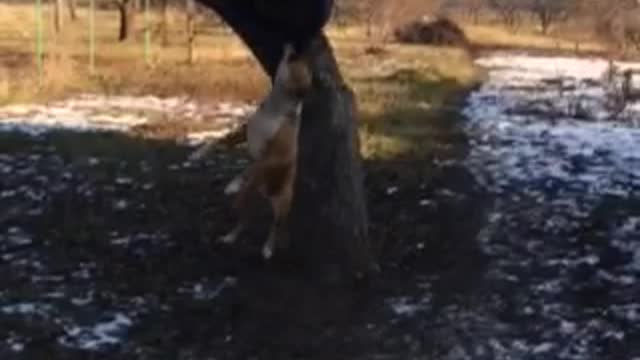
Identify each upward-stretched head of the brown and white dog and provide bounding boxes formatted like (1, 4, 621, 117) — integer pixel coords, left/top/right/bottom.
(274, 44, 313, 98)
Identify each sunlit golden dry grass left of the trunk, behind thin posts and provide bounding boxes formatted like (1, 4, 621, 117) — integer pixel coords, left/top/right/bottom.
(0, 5, 267, 103)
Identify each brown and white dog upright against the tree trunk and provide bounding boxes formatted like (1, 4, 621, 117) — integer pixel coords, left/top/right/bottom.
(191, 45, 311, 259)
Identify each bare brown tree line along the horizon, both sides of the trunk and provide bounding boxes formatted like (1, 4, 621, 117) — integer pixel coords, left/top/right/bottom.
(13, 0, 640, 57)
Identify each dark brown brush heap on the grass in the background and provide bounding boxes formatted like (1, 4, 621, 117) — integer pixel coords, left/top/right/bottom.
(394, 18, 469, 49)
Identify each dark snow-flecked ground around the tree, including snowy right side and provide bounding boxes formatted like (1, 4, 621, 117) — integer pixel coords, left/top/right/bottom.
(0, 52, 640, 360)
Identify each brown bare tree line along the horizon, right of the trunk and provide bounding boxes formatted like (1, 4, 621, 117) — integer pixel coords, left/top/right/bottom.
(334, 0, 640, 51)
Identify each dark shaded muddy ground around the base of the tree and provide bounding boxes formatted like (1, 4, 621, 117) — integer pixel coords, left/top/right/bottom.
(0, 91, 487, 359)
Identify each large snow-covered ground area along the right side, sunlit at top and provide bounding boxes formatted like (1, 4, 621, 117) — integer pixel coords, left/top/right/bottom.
(443, 55, 640, 360)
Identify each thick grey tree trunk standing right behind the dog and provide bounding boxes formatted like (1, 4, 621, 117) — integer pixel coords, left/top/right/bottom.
(290, 36, 374, 275)
